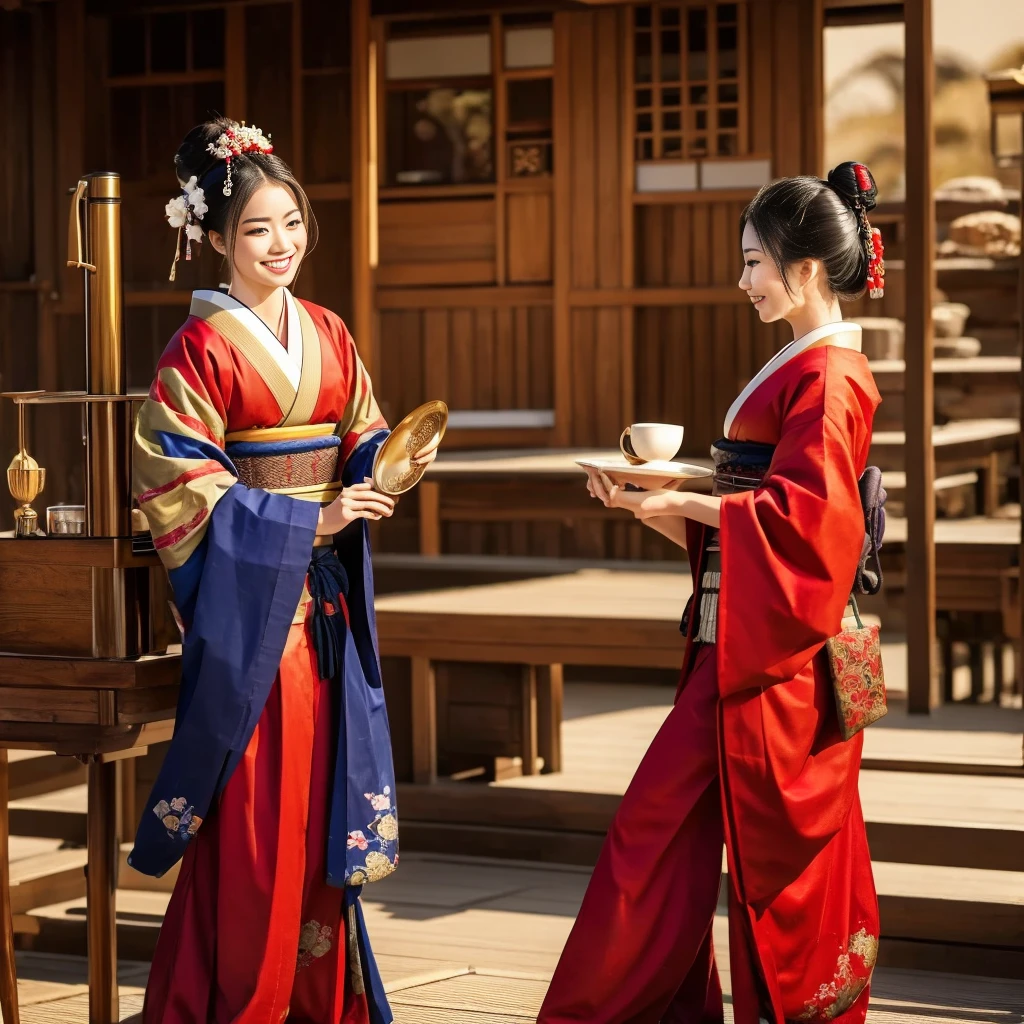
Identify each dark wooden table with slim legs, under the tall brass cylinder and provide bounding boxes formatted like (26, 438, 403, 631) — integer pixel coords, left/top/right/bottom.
(0, 535, 181, 1024)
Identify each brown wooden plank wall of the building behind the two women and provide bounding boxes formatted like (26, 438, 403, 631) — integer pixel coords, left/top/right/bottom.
(0, 0, 827, 553)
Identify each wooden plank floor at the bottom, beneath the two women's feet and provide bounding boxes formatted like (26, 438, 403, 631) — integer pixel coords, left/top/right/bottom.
(18, 854, 1024, 1024)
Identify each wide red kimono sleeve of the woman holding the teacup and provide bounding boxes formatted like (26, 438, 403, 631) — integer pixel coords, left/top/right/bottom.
(719, 360, 873, 696)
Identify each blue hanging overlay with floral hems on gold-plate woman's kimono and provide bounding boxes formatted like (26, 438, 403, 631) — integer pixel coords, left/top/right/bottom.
(128, 431, 397, 1024)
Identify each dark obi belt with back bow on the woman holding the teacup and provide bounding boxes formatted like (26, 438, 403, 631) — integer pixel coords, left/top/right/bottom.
(683, 439, 886, 643)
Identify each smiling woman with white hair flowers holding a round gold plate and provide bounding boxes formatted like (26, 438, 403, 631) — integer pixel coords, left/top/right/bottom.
(129, 118, 437, 1024)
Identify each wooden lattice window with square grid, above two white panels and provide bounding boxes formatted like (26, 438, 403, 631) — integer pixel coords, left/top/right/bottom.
(634, 0, 746, 161)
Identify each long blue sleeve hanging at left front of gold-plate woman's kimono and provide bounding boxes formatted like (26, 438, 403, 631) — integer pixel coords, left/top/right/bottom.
(130, 484, 319, 876)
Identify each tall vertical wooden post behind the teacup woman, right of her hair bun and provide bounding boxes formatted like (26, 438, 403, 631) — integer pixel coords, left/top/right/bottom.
(904, 0, 941, 714)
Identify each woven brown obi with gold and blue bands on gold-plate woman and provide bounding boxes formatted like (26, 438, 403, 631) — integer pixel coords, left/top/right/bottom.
(224, 423, 348, 630)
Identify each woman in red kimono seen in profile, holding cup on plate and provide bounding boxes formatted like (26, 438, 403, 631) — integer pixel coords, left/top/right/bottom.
(539, 164, 882, 1024)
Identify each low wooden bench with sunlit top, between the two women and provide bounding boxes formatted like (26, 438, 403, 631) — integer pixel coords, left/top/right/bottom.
(377, 564, 691, 783)
